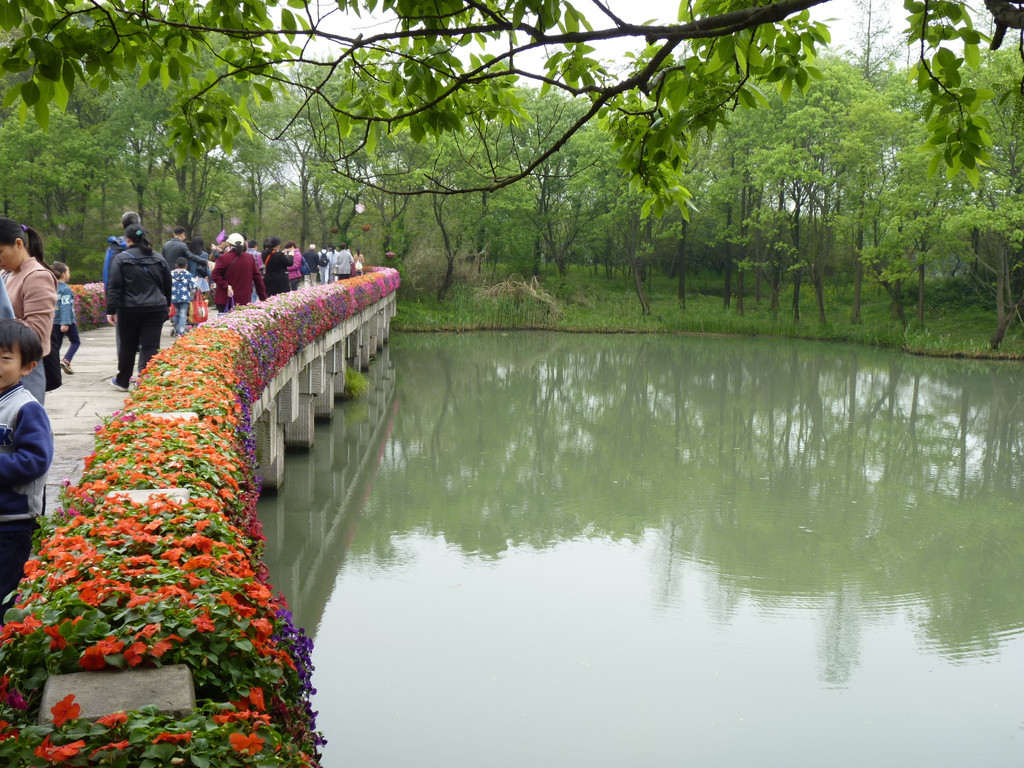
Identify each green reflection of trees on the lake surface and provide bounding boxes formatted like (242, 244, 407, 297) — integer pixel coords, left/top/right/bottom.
(260, 333, 1024, 685)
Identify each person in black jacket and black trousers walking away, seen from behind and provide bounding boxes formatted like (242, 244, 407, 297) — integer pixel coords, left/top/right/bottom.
(106, 225, 171, 392)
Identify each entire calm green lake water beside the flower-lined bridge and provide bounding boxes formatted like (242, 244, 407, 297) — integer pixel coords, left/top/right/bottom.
(260, 333, 1024, 768)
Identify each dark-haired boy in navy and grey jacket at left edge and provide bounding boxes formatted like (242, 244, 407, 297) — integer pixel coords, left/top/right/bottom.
(0, 319, 53, 626)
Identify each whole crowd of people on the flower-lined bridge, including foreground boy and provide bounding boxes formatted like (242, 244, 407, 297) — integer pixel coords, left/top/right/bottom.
(0, 211, 376, 627)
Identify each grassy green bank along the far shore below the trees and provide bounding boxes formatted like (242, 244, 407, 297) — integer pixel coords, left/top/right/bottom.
(391, 269, 1024, 359)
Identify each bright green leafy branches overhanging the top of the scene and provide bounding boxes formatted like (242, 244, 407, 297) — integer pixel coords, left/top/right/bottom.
(0, 0, 1007, 216)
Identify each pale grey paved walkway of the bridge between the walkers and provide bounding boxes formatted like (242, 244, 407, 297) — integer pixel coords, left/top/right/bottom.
(45, 323, 174, 513)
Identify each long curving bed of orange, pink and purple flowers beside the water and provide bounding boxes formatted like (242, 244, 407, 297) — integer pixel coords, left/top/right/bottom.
(0, 269, 398, 768)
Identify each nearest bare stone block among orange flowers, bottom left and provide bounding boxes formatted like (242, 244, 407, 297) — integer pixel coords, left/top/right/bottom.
(39, 664, 196, 725)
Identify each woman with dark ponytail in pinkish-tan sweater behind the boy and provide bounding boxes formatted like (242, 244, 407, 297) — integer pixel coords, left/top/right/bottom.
(0, 217, 57, 403)
